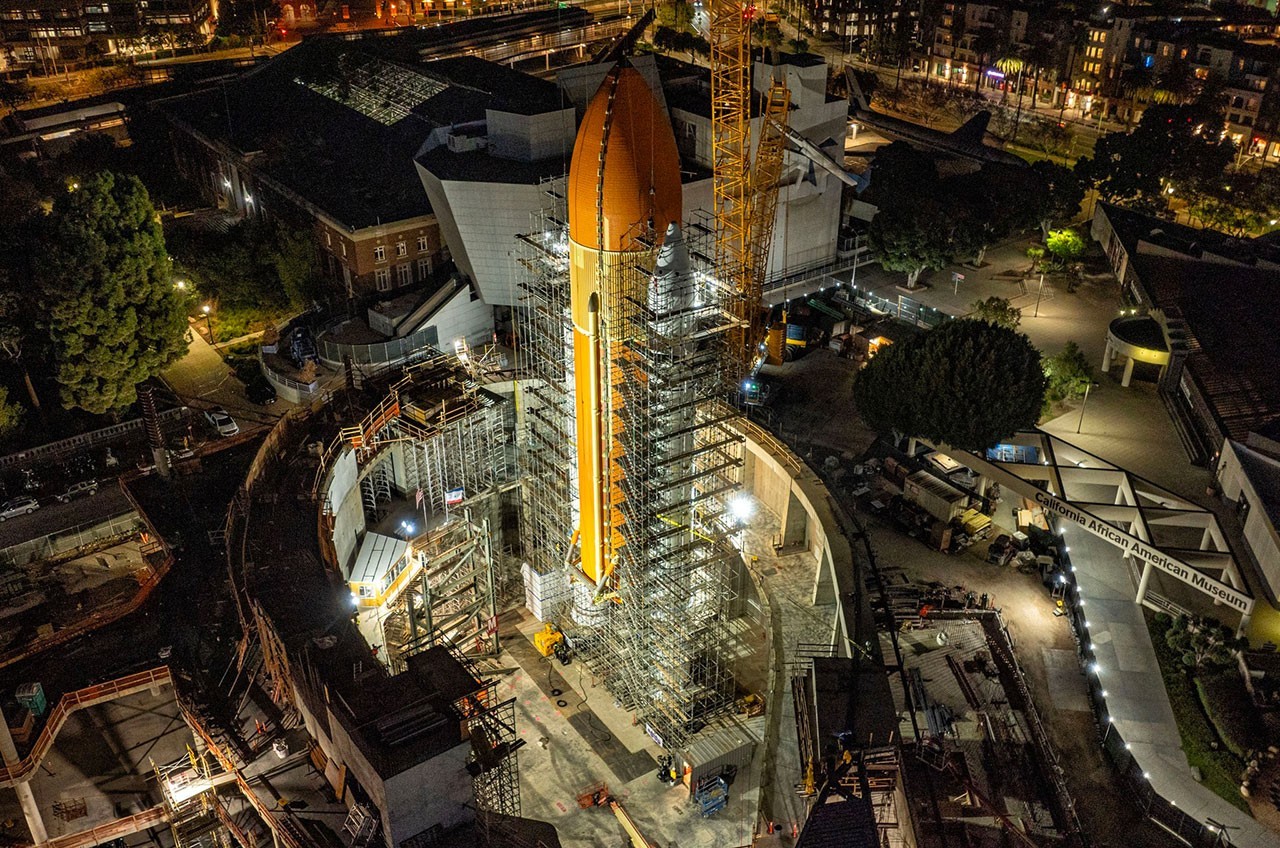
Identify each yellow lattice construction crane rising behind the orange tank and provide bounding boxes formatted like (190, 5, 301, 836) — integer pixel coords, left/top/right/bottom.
(710, 0, 791, 378)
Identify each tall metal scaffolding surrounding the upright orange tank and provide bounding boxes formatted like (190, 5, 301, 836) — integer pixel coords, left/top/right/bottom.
(518, 193, 742, 747)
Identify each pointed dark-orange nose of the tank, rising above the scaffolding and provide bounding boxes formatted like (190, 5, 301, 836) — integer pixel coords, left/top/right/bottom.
(568, 64, 682, 251)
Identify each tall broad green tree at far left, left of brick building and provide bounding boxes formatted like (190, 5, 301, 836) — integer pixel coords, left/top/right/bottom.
(35, 170, 187, 414)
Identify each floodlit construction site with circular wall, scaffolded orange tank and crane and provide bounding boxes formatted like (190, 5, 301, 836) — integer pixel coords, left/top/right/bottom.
(0, 0, 1100, 848)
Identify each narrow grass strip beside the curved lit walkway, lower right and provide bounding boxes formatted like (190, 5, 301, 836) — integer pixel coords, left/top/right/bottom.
(1144, 610, 1252, 815)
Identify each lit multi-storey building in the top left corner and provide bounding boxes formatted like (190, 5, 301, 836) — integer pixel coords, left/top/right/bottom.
(0, 0, 216, 73)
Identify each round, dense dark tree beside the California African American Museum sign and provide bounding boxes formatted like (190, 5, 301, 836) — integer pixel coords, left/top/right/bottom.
(854, 319, 1044, 451)
